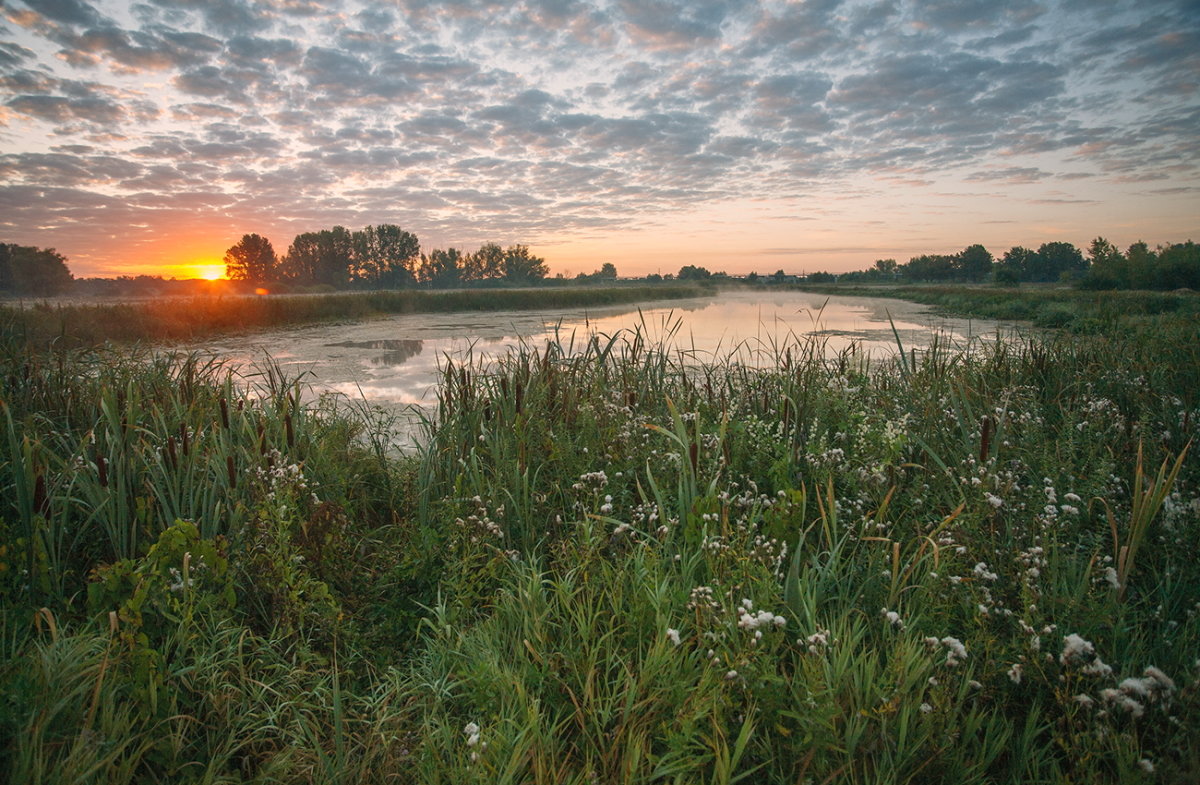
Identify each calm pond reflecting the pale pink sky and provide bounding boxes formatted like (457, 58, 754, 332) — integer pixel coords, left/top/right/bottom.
(192, 290, 1001, 447)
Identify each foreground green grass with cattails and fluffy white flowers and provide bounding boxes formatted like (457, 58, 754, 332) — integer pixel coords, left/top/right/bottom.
(0, 290, 1200, 784)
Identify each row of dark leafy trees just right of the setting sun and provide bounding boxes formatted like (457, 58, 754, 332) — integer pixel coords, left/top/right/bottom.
(224, 223, 552, 289)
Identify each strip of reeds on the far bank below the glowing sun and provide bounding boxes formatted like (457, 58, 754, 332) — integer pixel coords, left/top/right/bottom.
(0, 283, 713, 346)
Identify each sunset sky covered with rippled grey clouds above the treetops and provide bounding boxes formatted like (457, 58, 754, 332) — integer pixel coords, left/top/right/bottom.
(0, 0, 1200, 277)
